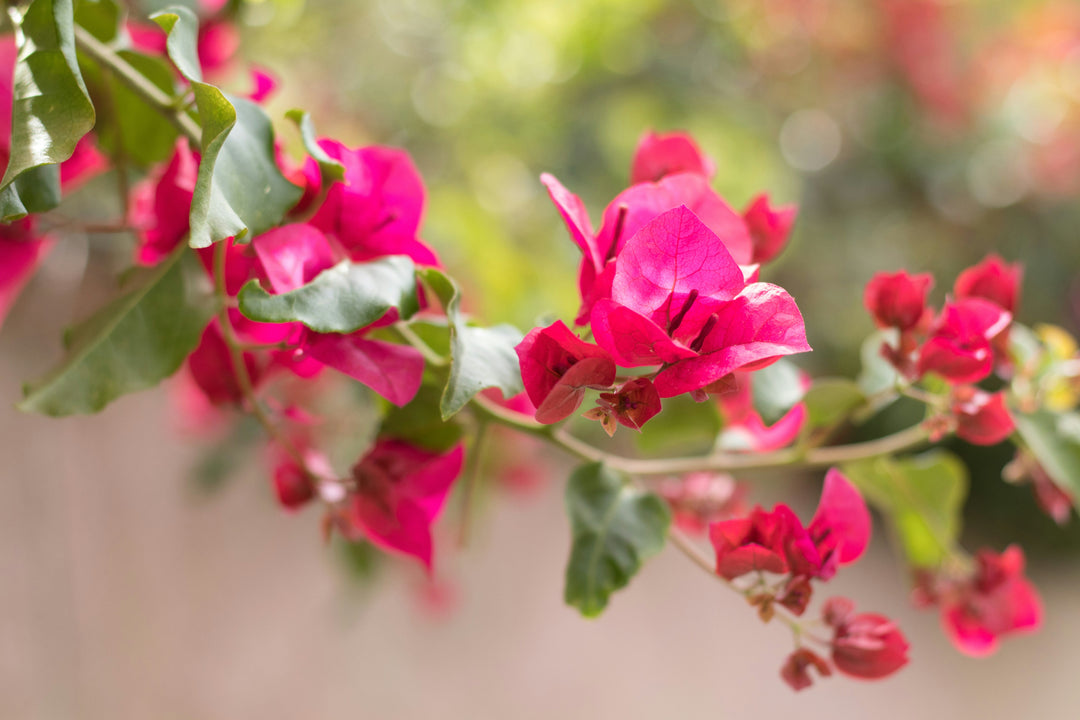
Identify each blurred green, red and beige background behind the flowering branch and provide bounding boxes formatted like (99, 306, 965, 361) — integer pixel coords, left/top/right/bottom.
(0, 0, 1080, 720)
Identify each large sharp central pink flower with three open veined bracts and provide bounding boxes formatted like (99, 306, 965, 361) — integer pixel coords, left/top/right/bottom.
(591, 207, 810, 397)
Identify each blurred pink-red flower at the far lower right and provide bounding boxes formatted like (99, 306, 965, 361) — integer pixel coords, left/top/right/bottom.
(942, 545, 1042, 657)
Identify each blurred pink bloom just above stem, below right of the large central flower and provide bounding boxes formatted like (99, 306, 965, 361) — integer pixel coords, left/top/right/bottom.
(717, 372, 810, 452)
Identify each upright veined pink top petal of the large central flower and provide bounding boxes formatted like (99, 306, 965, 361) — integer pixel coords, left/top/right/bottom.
(611, 206, 744, 327)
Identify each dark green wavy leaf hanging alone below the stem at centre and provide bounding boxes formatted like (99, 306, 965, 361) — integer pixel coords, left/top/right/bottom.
(565, 463, 671, 617)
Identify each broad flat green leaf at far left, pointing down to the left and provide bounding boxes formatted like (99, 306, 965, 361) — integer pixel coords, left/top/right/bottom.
(18, 245, 213, 416)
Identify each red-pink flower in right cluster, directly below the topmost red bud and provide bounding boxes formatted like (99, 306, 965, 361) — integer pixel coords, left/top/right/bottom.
(918, 298, 1012, 383)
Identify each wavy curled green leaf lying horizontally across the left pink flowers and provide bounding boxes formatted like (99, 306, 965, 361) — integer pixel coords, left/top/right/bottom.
(239, 255, 419, 332)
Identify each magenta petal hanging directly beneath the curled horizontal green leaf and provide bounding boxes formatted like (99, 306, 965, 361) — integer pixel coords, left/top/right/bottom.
(303, 332, 423, 407)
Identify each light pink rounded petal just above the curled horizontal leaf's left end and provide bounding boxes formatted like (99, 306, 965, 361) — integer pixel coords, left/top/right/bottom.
(252, 223, 334, 294)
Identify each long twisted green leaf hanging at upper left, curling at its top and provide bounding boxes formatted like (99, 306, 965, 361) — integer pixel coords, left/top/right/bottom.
(152, 8, 301, 247)
